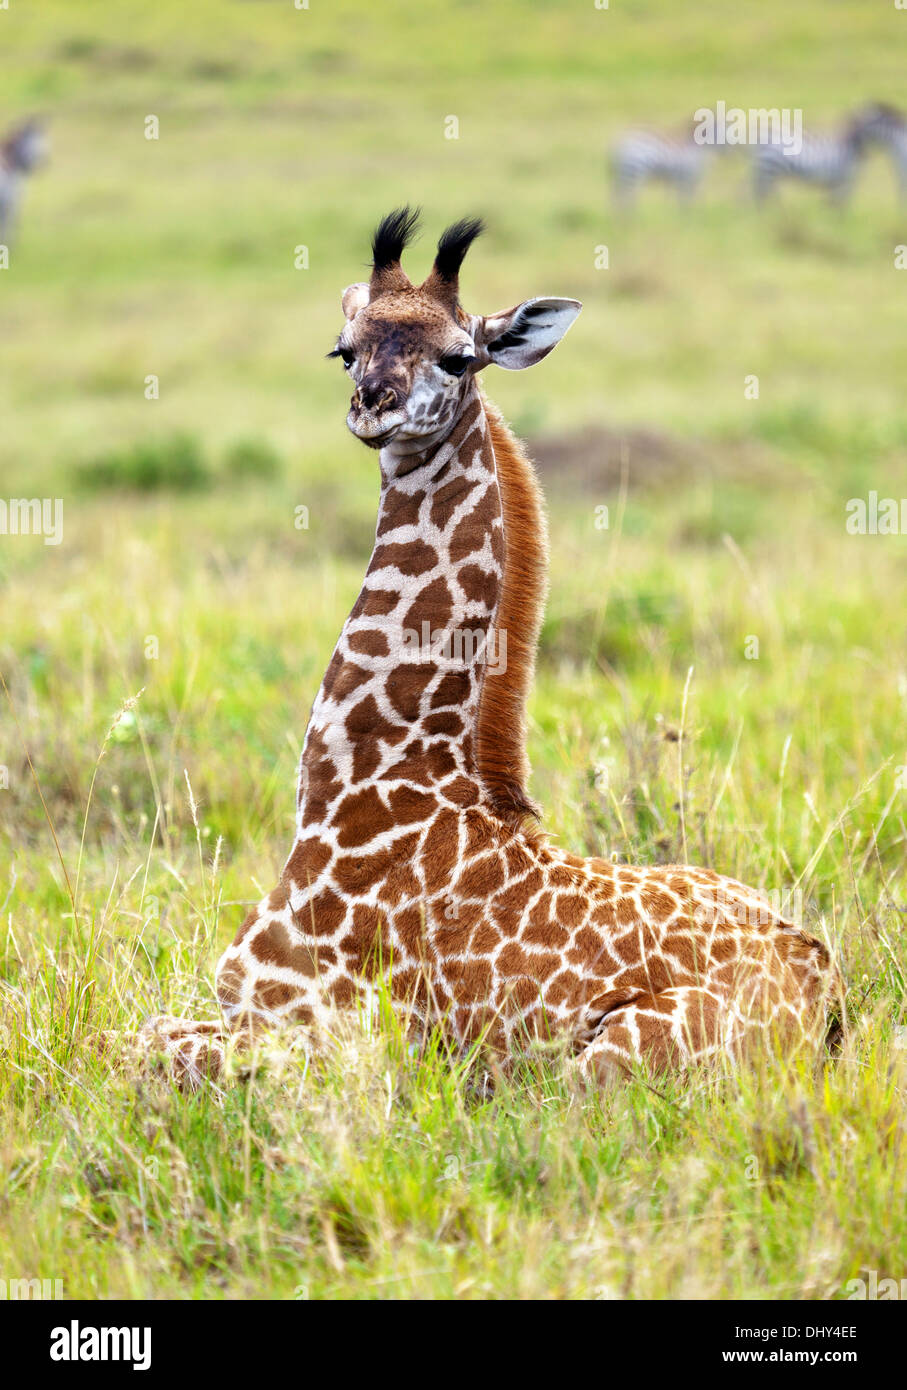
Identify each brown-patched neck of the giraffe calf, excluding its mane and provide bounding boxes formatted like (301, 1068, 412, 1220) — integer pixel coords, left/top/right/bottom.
(297, 381, 508, 837)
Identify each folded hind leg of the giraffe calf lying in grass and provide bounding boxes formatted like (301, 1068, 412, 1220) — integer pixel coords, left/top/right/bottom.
(575, 986, 746, 1086)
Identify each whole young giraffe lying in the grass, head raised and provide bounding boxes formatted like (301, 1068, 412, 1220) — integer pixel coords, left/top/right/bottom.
(134, 209, 839, 1084)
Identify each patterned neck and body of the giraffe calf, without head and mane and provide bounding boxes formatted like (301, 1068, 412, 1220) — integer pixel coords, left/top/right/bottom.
(201, 382, 836, 1083)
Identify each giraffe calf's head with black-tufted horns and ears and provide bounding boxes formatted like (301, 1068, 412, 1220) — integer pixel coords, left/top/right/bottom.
(331, 207, 582, 456)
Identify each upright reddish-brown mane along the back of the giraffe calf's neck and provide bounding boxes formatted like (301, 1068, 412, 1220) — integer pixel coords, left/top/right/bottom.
(476, 396, 549, 833)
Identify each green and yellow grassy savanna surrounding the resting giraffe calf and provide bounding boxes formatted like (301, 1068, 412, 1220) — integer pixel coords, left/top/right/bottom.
(0, 0, 907, 1300)
